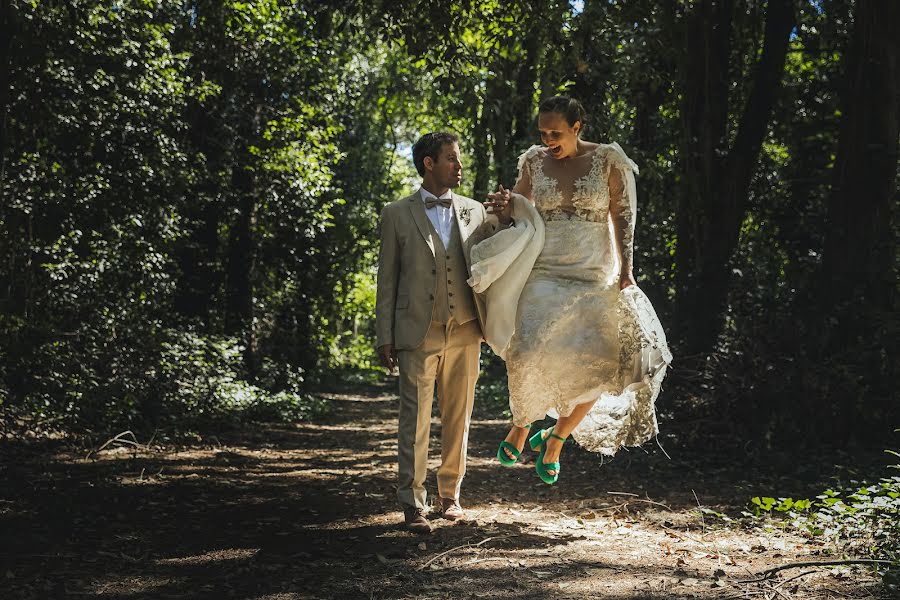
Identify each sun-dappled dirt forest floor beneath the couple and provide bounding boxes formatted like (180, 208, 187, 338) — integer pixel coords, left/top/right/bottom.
(0, 383, 888, 600)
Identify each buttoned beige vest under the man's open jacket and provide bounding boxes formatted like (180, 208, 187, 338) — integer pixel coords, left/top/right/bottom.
(428, 219, 478, 324)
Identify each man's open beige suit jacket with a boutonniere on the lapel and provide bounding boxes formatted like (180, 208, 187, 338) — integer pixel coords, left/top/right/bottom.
(375, 190, 499, 350)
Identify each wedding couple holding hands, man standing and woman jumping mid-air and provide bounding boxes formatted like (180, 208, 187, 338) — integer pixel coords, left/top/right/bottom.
(376, 96, 672, 533)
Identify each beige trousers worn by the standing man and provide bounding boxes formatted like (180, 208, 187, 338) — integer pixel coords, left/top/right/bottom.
(397, 319, 481, 508)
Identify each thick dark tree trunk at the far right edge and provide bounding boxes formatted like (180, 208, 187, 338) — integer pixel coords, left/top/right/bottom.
(821, 0, 900, 316)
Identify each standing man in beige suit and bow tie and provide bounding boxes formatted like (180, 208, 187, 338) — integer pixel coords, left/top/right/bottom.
(375, 133, 509, 533)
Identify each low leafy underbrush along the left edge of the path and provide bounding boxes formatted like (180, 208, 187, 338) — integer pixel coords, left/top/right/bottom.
(0, 330, 329, 437)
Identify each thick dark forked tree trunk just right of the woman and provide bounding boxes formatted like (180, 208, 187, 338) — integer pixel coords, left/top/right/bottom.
(676, 0, 795, 355)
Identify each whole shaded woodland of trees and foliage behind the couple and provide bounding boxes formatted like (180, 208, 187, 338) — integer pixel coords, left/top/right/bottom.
(0, 0, 900, 450)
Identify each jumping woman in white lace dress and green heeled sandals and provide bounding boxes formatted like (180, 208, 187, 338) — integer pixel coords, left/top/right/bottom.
(487, 96, 671, 484)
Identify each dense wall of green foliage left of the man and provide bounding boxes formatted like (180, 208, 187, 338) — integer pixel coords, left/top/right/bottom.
(0, 0, 358, 429)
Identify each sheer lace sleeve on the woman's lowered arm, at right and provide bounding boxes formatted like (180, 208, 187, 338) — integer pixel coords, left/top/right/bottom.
(606, 143, 638, 275)
